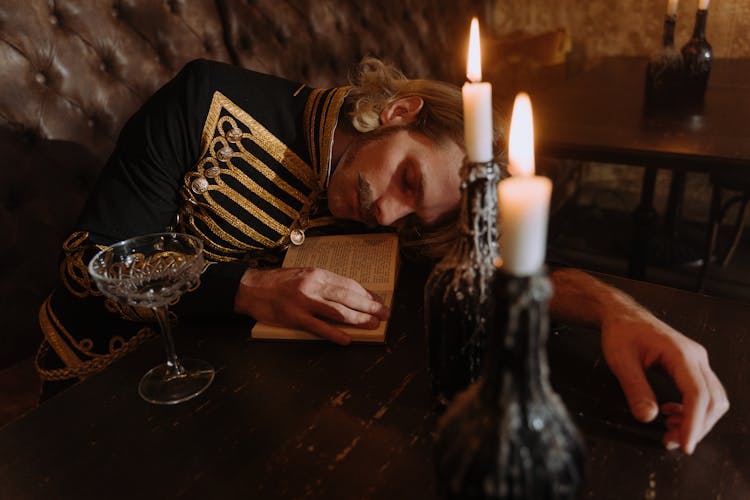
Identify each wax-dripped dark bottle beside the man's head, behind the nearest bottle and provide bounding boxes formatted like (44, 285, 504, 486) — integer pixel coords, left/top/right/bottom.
(424, 161, 500, 406)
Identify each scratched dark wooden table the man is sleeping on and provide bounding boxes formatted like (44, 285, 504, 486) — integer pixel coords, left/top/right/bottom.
(0, 266, 750, 500)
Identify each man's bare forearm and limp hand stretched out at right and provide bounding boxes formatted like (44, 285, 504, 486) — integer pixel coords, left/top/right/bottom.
(550, 269, 729, 454)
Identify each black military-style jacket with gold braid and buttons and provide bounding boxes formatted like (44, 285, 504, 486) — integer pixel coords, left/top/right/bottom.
(37, 60, 347, 380)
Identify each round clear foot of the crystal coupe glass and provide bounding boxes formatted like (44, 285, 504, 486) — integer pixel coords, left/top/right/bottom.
(138, 358, 216, 405)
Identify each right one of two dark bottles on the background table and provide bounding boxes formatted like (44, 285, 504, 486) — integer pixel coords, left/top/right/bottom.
(682, 9, 714, 102)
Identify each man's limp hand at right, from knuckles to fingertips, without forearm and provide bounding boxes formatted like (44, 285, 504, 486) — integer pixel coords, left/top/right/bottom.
(602, 308, 729, 454)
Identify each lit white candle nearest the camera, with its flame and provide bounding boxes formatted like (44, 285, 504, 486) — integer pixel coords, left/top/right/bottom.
(497, 93, 552, 276)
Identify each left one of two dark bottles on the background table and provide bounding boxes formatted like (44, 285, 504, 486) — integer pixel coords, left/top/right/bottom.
(645, 14, 683, 106)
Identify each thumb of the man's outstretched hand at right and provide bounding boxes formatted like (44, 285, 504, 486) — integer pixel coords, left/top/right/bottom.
(609, 351, 659, 422)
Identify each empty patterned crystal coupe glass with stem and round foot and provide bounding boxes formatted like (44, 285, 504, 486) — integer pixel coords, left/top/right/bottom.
(89, 233, 215, 404)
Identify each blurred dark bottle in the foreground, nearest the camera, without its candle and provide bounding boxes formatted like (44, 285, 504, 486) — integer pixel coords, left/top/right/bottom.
(435, 273, 583, 500)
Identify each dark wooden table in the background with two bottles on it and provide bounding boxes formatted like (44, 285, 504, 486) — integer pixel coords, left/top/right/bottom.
(531, 57, 750, 279)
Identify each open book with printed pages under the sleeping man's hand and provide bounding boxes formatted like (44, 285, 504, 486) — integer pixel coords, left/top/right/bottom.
(250, 233, 398, 342)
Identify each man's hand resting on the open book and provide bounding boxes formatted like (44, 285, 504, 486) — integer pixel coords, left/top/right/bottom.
(234, 268, 390, 345)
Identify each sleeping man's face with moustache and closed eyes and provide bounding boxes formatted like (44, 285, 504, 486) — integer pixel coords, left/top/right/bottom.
(328, 127, 464, 226)
